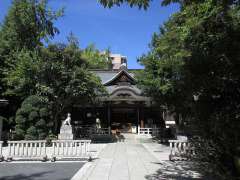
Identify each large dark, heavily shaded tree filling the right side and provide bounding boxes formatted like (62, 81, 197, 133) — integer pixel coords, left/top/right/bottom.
(136, 0, 240, 178)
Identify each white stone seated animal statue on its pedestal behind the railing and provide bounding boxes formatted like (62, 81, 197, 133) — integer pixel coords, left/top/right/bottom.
(58, 113, 73, 140)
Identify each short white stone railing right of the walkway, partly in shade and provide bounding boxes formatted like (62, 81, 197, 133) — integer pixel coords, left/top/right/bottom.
(169, 140, 195, 160)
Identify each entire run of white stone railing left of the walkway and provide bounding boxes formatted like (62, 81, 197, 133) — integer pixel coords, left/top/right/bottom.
(0, 140, 91, 161)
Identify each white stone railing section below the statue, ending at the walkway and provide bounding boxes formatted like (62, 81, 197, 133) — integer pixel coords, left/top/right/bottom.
(52, 140, 91, 161)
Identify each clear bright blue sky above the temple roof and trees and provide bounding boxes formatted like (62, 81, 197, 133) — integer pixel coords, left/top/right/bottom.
(0, 0, 179, 69)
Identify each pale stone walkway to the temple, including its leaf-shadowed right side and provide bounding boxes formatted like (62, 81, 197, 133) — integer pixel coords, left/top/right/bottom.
(78, 134, 205, 180)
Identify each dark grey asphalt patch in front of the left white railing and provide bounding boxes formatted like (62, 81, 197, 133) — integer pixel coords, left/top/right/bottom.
(0, 162, 84, 180)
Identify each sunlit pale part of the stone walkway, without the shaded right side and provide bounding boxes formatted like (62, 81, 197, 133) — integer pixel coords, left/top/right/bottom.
(82, 135, 161, 180)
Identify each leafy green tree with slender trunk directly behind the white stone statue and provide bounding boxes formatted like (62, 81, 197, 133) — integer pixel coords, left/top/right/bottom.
(37, 42, 104, 132)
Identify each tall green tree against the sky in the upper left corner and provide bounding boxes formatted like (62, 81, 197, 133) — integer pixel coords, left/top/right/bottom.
(0, 0, 63, 97)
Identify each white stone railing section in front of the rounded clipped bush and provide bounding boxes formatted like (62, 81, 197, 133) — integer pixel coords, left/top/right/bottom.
(7, 140, 47, 160)
